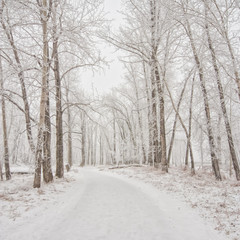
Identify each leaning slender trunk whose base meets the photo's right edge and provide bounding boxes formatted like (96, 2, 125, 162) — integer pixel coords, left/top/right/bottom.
(205, 3, 240, 181)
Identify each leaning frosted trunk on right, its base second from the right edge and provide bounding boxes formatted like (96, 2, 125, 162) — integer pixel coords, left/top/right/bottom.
(186, 18, 222, 180)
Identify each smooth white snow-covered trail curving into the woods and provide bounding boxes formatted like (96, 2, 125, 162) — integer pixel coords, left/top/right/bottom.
(0, 169, 225, 240)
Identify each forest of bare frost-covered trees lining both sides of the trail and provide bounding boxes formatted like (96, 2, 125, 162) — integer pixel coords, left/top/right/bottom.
(0, 0, 240, 188)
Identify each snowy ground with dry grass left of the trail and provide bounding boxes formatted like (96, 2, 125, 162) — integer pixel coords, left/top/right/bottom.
(0, 167, 77, 223)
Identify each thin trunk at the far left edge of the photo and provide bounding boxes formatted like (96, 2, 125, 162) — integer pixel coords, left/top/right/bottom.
(0, 51, 11, 180)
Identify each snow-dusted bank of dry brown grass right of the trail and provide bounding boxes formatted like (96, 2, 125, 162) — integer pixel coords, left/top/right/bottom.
(104, 167, 240, 240)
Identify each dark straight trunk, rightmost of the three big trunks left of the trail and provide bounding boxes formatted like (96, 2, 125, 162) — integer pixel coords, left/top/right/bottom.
(53, 1, 64, 178)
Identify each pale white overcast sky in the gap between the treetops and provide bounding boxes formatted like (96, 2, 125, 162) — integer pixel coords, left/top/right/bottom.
(81, 0, 123, 94)
